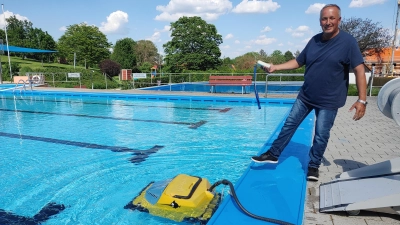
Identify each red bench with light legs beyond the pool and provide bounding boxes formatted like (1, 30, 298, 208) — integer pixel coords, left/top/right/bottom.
(208, 76, 252, 94)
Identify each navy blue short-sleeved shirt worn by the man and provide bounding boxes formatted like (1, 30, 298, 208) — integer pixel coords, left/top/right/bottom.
(296, 30, 364, 109)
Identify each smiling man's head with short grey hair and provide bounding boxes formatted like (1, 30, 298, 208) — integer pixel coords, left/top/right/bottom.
(319, 7, 342, 35)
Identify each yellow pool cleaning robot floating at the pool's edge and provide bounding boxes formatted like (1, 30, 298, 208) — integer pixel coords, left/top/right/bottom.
(125, 174, 221, 224)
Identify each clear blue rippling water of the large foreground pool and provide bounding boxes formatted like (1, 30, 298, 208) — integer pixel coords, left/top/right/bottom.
(0, 91, 292, 225)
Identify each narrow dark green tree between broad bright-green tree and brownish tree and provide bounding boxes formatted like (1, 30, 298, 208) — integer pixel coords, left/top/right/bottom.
(111, 38, 136, 69)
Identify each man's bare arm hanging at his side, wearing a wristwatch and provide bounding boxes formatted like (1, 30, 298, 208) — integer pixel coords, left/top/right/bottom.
(350, 63, 367, 120)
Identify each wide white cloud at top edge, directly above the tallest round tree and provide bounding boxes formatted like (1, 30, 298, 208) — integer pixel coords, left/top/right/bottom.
(155, 0, 232, 22)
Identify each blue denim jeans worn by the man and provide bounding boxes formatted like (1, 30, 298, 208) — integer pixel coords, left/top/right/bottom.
(268, 99, 338, 168)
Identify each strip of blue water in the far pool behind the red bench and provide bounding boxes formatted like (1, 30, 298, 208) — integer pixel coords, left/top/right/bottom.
(142, 82, 303, 94)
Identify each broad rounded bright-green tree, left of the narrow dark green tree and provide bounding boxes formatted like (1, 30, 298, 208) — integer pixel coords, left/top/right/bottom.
(58, 23, 111, 68)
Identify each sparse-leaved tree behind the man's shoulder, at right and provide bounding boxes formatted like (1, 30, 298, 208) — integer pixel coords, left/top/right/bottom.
(339, 17, 392, 55)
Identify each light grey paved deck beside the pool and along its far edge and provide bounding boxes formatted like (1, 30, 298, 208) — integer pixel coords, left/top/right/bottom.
(29, 88, 400, 225)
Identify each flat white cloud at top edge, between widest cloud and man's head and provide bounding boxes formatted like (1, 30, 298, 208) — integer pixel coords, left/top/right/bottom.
(232, 0, 281, 13)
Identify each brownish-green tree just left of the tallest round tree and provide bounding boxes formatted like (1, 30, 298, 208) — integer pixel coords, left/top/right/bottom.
(136, 40, 158, 67)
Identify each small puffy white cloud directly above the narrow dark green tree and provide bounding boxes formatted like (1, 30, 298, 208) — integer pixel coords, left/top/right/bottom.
(99, 10, 129, 34)
